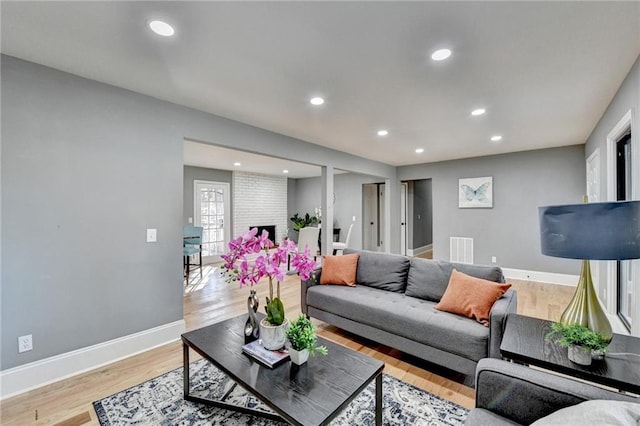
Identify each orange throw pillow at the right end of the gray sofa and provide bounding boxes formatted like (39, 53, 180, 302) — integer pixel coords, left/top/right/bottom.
(435, 269, 511, 327)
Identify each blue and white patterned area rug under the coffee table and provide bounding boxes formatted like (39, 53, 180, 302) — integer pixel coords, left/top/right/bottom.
(93, 359, 468, 426)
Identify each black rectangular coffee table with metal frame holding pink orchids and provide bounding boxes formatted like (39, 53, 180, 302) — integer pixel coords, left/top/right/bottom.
(182, 315, 384, 425)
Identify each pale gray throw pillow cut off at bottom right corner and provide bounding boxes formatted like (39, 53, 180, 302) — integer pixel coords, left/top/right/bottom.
(531, 399, 640, 426)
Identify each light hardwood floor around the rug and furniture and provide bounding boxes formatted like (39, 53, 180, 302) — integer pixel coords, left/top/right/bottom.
(0, 265, 574, 426)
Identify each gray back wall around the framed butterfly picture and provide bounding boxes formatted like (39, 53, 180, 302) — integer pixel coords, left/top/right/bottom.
(398, 145, 585, 274)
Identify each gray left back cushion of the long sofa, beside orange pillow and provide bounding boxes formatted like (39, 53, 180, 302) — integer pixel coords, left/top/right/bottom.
(344, 249, 410, 293)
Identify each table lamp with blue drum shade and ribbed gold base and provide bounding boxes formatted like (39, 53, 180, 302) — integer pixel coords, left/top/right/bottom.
(538, 201, 640, 340)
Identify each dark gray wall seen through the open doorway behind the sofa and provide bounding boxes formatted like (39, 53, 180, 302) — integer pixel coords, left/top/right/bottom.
(407, 179, 433, 249)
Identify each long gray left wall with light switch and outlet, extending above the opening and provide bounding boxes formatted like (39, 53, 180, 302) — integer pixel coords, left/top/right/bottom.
(0, 55, 395, 370)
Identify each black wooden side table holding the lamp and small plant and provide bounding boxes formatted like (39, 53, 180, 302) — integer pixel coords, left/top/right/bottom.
(500, 314, 640, 394)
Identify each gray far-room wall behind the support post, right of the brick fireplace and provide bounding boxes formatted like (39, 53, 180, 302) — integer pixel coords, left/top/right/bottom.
(294, 173, 380, 249)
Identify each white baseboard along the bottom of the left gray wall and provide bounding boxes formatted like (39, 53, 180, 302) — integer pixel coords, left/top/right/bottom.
(0, 320, 185, 400)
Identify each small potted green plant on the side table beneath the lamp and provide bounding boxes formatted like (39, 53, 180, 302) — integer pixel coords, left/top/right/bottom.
(545, 322, 609, 365)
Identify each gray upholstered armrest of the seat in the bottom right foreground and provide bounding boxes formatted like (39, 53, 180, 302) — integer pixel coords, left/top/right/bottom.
(476, 358, 638, 424)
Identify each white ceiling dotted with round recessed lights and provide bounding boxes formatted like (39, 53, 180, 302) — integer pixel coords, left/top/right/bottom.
(1, 1, 640, 175)
